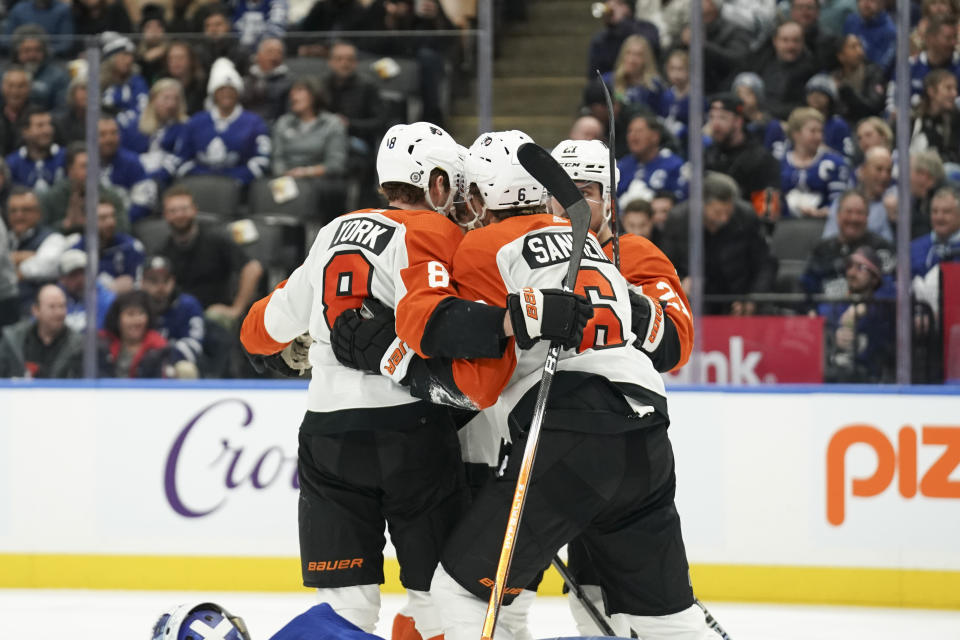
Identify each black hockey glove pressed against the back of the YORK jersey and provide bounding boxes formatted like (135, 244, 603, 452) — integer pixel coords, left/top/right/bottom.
(330, 298, 397, 373)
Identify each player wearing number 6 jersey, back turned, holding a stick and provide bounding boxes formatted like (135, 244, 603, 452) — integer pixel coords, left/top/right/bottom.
(330, 132, 707, 640)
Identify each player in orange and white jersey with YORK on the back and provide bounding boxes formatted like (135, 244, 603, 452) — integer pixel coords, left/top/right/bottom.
(241, 123, 584, 638)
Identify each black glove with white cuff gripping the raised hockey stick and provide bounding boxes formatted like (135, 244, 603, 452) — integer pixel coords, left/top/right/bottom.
(507, 287, 593, 349)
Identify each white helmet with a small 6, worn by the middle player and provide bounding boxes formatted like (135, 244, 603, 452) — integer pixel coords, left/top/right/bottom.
(463, 130, 546, 217)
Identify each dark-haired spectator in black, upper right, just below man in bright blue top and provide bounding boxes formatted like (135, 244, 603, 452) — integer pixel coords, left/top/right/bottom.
(830, 33, 886, 122)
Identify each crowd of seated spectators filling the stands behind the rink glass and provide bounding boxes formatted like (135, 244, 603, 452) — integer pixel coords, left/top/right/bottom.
(0, 0, 960, 382)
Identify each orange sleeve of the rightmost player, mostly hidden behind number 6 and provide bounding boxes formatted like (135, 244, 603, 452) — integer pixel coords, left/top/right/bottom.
(603, 233, 693, 371)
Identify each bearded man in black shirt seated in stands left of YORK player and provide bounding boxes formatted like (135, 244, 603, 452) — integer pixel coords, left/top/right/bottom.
(160, 185, 263, 325)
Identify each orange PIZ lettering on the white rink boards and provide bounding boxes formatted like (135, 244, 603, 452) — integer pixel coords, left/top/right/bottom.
(827, 424, 960, 525)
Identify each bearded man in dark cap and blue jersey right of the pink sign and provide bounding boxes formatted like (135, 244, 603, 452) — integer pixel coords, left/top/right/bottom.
(819, 246, 896, 383)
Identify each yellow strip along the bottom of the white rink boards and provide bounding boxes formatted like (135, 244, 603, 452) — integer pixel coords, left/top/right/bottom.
(0, 554, 960, 609)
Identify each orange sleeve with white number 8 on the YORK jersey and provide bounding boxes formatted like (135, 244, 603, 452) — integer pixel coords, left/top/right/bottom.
(382, 210, 463, 356)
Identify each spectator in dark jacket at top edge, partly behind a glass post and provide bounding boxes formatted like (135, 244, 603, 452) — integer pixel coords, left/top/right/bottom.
(680, 0, 750, 95)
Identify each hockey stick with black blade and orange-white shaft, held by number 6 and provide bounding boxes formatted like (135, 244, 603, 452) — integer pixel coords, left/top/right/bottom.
(481, 142, 590, 640)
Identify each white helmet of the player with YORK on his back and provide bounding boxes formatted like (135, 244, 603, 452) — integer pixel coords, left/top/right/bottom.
(377, 122, 463, 213)
